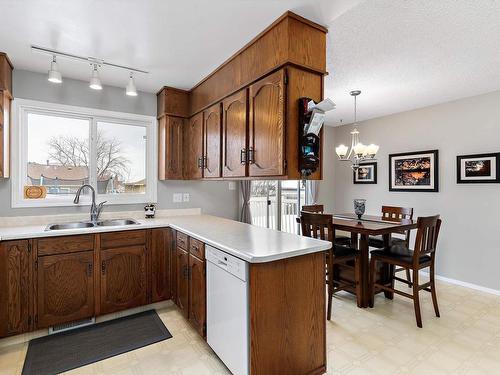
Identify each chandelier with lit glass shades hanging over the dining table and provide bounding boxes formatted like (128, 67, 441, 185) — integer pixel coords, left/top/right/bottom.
(335, 90, 379, 170)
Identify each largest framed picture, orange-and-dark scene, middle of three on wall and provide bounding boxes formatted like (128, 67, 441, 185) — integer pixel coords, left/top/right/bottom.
(389, 150, 439, 192)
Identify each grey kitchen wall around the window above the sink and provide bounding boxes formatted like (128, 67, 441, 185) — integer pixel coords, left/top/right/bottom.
(0, 70, 239, 219)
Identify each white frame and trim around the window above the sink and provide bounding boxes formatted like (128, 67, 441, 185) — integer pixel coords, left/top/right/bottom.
(11, 99, 158, 208)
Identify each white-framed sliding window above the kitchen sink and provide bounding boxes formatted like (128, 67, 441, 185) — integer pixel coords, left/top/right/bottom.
(12, 99, 156, 207)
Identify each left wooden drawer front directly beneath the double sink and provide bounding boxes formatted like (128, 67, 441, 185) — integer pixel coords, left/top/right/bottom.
(37, 234, 94, 256)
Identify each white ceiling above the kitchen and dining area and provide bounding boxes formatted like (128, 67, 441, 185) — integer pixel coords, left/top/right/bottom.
(0, 0, 500, 125)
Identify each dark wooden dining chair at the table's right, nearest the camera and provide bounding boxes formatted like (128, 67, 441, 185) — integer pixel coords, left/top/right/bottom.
(370, 215, 441, 328)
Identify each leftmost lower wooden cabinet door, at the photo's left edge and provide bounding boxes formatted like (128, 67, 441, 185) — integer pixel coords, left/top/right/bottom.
(0, 240, 32, 337)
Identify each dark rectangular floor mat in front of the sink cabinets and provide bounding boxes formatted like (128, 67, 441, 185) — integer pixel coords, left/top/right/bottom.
(23, 310, 172, 375)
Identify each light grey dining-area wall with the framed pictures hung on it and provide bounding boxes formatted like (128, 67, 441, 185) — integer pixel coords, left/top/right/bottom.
(319, 91, 500, 290)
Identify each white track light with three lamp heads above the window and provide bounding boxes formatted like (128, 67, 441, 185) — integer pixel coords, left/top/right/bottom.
(31, 46, 149, 96)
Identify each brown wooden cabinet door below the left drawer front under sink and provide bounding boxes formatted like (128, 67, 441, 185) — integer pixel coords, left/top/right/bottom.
(36, 251, 94, 328)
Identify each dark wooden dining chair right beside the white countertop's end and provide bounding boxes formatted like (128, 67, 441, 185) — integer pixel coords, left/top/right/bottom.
(300, 211, 360, 320)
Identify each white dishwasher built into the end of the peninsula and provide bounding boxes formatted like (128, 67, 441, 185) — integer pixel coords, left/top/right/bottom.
(205, 246, 250, 375)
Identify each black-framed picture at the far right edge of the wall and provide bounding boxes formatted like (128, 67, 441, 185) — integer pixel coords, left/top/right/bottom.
(457, 152, 500, 184)
